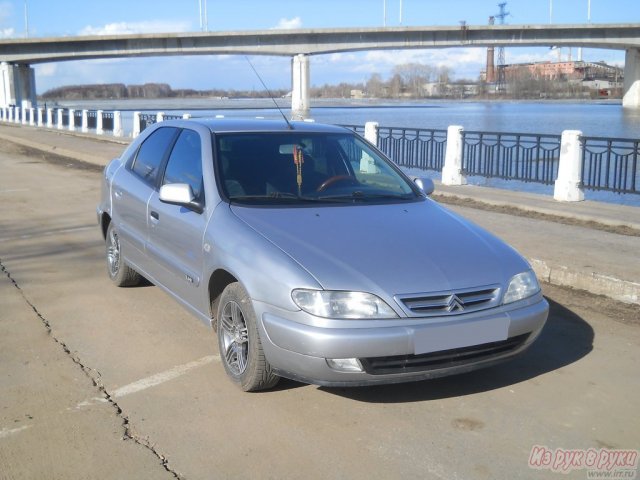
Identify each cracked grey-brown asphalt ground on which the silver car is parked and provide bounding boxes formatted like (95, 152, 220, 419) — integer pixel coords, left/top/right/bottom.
(0, 143, 640, 479)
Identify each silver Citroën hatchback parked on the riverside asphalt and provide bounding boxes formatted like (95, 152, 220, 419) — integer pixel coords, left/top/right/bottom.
(97, 119, 548, 391)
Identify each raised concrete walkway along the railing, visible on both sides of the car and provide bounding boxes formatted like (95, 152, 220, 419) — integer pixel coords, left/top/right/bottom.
(0, 124, 640, 306)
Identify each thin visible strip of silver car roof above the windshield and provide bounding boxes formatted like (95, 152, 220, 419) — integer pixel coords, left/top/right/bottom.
(162, 118, 347, 133)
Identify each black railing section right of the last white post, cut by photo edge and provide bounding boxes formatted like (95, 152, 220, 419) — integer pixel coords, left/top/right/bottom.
(582, 137, 640, 193)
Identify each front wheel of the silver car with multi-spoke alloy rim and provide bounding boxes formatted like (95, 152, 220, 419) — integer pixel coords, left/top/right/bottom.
(217, 282, 280, 392)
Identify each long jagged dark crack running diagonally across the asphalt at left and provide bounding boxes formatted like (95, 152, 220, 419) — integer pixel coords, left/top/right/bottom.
(0, 258, 183, 480)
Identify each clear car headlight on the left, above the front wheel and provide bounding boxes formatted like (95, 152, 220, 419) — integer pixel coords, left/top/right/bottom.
(291, 289, 398, 319)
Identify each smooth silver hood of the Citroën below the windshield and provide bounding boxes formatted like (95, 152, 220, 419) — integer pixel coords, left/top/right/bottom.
(231, 199, 529, 300)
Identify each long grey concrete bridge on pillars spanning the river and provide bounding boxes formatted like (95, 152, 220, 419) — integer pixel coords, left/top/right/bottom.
(0, 24, 640, 114)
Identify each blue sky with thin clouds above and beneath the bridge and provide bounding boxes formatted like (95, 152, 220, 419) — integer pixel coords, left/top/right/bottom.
(0, 0, 640, 92)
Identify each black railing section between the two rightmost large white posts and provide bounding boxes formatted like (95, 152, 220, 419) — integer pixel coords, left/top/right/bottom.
(462, 131, 561, 185)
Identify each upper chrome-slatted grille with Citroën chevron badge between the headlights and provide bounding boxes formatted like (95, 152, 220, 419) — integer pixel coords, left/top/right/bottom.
(396, 285, 500, 317)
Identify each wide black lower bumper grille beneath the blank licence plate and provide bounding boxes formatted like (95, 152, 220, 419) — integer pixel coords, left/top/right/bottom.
(360, 333, 529, 375)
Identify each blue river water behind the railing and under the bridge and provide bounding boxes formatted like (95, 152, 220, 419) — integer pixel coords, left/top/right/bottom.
(60, 99, 640, 206)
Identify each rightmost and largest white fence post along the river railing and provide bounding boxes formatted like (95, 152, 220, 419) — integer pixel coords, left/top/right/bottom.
(553, 130, 584, 202)
